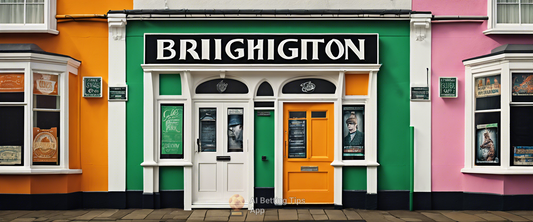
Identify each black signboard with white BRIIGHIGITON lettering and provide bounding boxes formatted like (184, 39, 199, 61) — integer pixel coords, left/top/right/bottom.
(144, 34, 378, 64)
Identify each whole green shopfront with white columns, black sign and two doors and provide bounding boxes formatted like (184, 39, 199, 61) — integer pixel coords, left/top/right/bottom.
(109, 7, 431, 209)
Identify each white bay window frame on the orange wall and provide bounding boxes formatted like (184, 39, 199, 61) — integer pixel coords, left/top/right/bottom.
(0, 53, 82, 175)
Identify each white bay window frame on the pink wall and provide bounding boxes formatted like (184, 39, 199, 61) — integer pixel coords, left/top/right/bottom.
(461, 53, 533, 175)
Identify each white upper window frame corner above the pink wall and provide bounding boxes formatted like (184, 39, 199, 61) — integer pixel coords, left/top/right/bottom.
(483, 0, 533, 35)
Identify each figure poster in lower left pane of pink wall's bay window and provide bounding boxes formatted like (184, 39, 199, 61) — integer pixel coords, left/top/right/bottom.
(475, 123, 500, 165)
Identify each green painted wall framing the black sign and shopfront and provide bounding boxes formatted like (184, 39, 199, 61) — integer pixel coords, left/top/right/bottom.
(126, 20, 409, 190)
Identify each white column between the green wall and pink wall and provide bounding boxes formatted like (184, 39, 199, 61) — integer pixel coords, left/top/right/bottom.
(410, 14, 432, 192)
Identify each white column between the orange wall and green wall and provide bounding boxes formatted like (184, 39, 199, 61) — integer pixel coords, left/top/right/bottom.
(107, 14, 127, 192)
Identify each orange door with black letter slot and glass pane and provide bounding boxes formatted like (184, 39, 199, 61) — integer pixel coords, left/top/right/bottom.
(283, 103, 334, 204)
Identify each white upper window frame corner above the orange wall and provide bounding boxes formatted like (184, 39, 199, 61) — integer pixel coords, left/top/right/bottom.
(0, 0, 59, 35)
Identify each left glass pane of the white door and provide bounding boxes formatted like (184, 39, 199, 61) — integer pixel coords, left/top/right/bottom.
(199, 109, 217, 152)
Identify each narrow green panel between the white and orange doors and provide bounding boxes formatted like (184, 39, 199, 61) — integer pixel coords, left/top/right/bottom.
(254, 111, 275, 188)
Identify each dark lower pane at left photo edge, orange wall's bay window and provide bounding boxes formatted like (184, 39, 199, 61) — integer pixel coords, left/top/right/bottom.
(0, 106, 24, 165)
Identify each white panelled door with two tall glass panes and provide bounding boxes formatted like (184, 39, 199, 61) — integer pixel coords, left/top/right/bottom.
(192, 103, 251, 208)
